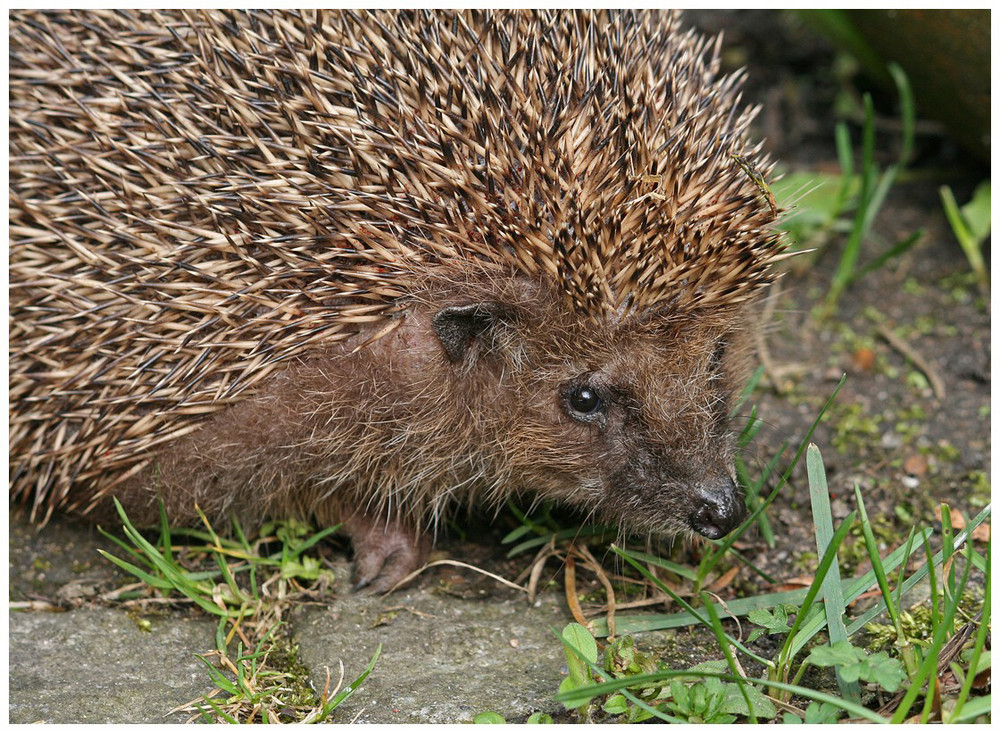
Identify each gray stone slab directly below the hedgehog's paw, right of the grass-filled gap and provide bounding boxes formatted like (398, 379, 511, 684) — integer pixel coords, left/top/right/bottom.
(295, 590, 567, 723)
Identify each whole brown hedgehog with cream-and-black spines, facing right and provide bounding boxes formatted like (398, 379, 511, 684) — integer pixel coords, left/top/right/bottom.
(9, 10, 787, 590)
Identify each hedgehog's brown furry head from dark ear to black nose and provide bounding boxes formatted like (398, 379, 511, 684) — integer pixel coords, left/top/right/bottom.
(434, 294, 746, 539)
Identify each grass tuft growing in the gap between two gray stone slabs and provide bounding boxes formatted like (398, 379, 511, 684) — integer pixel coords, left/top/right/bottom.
(99, 500, 381, 723)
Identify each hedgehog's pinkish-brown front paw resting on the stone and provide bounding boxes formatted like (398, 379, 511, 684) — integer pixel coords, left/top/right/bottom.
(344, 515, 429, 593)
